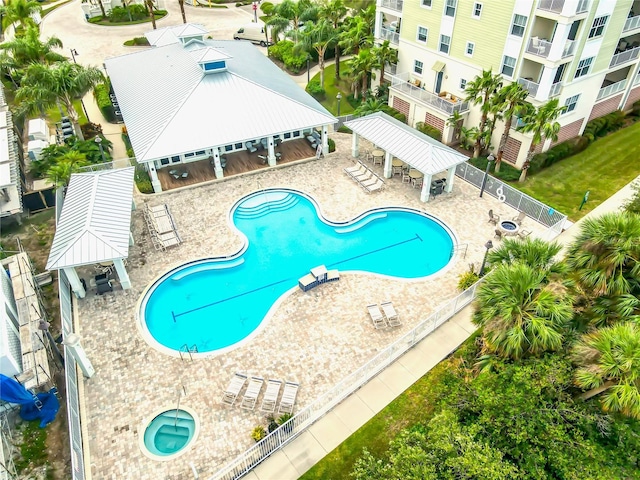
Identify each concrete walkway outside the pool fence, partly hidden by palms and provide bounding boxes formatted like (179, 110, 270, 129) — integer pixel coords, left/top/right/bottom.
(244, 176, 640, 480)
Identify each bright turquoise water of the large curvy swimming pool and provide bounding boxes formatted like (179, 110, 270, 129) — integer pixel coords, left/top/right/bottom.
(140, 190, 453, 352)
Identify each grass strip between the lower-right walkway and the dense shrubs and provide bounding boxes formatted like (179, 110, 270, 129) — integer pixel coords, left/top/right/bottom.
(300, 333, 479, 480)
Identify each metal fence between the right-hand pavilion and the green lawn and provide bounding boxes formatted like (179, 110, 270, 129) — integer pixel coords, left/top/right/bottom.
(456, 163, 567, 232)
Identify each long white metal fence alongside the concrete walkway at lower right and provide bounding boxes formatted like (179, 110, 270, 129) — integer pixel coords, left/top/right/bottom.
(209, 281, 482, 480)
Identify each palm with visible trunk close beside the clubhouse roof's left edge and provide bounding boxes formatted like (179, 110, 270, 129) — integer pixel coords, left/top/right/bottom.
(16, 62, 104, 140)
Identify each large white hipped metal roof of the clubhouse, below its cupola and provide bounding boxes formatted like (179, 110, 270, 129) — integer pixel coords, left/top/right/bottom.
(105, 40, 336, 162)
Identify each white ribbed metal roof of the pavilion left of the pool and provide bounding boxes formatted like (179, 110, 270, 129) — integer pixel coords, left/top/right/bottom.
(47, 167, 135, 270)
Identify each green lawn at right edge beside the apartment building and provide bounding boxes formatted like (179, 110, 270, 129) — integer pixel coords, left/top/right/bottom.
(513, 122, 640, 221)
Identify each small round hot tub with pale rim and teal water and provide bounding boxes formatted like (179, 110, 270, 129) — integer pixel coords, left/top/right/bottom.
(141, 409, 197, 460)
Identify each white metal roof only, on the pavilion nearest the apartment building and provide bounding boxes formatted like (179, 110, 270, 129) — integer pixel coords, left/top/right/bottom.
(345, 112, 469, 175)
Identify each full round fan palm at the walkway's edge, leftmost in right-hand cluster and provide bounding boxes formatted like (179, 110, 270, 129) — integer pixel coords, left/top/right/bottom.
(473, 262, 573, 359)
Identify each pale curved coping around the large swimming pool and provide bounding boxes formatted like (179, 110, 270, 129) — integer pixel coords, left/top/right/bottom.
(135, 187, 459, 359)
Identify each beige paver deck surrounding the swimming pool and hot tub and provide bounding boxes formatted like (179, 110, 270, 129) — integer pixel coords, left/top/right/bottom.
(77, 133, 545, 480)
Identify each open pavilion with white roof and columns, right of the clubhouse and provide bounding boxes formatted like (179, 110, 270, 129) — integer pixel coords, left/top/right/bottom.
(345, 112, 468, 202)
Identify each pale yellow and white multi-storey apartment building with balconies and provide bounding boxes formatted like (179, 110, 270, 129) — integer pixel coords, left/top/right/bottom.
(375, 0, 640, 167)
